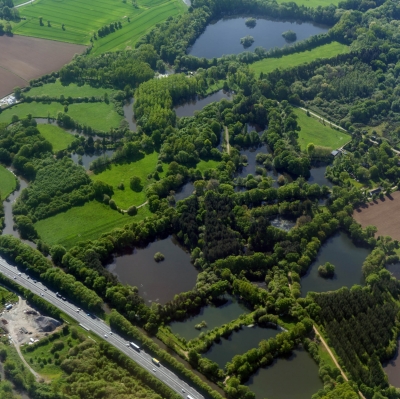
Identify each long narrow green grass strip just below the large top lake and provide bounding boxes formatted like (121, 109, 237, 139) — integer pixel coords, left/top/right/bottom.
(250, 42, 349, 76)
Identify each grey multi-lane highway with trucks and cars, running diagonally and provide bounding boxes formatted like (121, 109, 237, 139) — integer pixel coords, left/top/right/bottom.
(0, 257, 204, 399)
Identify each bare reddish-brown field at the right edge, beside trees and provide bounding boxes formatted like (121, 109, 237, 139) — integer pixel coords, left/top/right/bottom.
(353, 191, 400, 240)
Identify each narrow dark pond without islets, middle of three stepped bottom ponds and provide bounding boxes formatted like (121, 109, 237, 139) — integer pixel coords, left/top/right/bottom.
(204, 326, 282, 369)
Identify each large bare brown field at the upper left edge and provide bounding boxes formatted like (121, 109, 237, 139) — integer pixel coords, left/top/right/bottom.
(0, 35, 86, 98)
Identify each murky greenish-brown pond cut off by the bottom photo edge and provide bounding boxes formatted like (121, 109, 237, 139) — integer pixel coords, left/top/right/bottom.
(246, 348, 323, 399)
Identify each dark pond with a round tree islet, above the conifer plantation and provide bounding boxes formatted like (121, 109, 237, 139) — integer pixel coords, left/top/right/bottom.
(301, 232, 370, 296)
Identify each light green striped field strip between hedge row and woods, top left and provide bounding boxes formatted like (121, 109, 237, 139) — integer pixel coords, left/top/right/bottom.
(90, 0, 186, 56)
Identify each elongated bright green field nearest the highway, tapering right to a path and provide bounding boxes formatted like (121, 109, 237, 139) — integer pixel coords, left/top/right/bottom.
(35, 201, 150, 248)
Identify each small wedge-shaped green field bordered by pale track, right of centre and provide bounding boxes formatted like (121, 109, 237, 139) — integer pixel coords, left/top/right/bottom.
(294, 108, 351, 150)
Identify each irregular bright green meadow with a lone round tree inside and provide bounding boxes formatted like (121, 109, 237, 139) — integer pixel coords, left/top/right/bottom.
(91, 152, 159, 209)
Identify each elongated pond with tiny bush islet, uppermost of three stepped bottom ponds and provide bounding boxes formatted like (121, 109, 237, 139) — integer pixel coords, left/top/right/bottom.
(170, 295, 249, 340)
